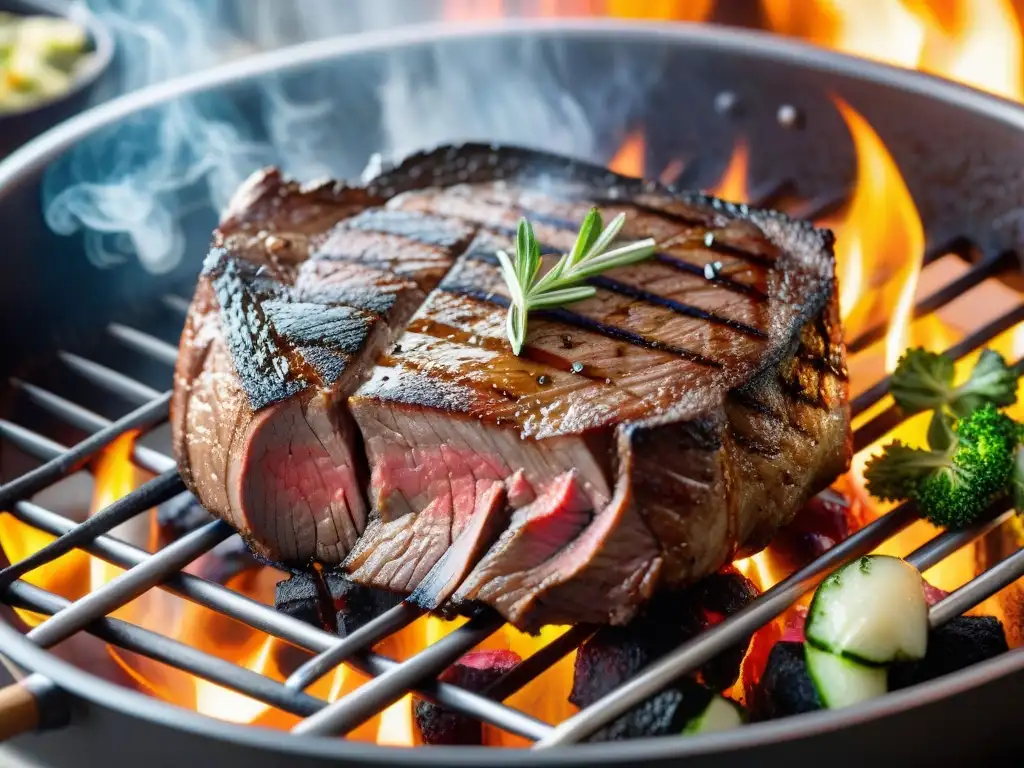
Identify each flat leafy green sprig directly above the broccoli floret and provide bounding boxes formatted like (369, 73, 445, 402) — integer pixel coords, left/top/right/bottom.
(889, 349, 1019, 417)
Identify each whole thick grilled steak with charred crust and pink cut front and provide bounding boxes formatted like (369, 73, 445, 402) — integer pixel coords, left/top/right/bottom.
(174, 145, 851, 629)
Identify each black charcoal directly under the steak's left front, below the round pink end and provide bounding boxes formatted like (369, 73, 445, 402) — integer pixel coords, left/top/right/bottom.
(274, 571, 401, 637)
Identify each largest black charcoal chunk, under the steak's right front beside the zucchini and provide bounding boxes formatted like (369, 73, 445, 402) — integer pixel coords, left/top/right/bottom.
(569, 570, 757, 708)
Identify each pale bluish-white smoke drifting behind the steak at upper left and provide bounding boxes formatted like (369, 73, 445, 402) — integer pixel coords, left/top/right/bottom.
(44, 0, 614, 273)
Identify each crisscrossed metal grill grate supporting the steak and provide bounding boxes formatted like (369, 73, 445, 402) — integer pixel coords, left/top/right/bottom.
(0, 217, 1024, 748)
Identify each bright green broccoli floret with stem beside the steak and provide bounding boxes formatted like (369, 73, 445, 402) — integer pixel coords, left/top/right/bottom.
(864, 404, 1018, 528)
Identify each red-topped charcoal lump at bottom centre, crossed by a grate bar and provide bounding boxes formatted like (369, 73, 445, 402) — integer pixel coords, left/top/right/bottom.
(413, 650, 522, 746)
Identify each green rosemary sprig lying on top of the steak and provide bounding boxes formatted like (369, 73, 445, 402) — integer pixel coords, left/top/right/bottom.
(498, 208, 655, 354)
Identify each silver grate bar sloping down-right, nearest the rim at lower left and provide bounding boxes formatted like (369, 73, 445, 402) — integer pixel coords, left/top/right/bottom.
(7, 582, 327, 717)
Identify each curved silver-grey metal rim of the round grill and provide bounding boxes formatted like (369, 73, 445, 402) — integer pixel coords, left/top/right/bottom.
(0, 18, 1024, 766)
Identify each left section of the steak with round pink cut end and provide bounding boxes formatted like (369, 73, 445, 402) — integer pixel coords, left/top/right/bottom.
(172, 173, 472, 566)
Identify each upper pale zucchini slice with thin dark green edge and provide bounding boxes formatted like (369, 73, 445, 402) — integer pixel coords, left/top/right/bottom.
(804, 555, 928, 666)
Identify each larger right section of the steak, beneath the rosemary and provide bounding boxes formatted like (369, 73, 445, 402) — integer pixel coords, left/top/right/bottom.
(346, 145, 851, 630)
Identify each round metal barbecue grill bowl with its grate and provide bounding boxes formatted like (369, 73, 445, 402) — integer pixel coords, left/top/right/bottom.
(0, 20, 1024, 768)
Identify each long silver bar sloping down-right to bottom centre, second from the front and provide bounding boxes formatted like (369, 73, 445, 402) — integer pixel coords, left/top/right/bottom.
(6, 502, 550, 739)
